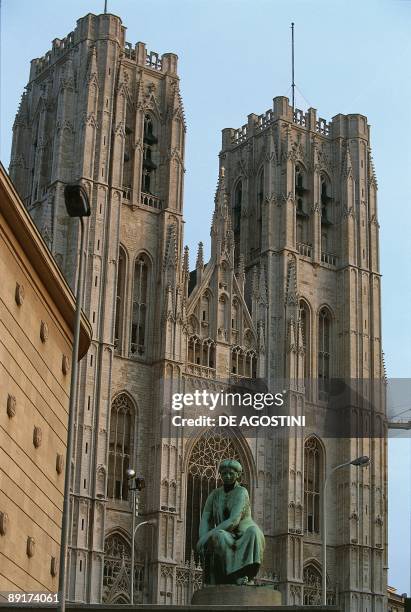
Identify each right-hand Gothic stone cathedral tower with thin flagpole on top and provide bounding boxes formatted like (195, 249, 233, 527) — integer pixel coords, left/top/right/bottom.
(220, 97, 386, 610)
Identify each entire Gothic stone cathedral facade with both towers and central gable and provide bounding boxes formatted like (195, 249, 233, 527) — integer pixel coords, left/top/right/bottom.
(10, 10, 387, 611)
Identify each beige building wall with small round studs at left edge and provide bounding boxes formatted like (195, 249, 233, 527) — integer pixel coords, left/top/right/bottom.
(0, 168, 91, 592)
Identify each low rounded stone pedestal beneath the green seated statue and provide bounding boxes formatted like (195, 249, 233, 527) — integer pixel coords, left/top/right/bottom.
(191, 584, 281, 608)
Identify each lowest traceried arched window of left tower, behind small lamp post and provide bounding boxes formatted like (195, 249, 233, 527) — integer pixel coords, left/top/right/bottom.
(103, 533, 144, 604)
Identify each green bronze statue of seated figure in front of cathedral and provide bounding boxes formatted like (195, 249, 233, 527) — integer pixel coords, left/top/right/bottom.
(197, 459, 265, 585)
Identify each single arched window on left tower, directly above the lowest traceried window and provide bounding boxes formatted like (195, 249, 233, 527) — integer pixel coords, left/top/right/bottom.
(107, 393, 134, 499)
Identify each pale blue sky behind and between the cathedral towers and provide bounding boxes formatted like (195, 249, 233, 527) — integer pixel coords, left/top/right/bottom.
(1, 0, 411, 592)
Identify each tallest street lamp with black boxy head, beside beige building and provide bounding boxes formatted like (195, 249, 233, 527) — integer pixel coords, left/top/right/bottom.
(58, 185, 91, 612)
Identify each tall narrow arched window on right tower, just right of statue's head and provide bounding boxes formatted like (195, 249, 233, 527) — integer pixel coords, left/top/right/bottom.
(304, 437, 324, 535)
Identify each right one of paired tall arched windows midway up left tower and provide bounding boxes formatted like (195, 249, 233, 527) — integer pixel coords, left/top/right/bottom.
(130, 255, 149, 356)
